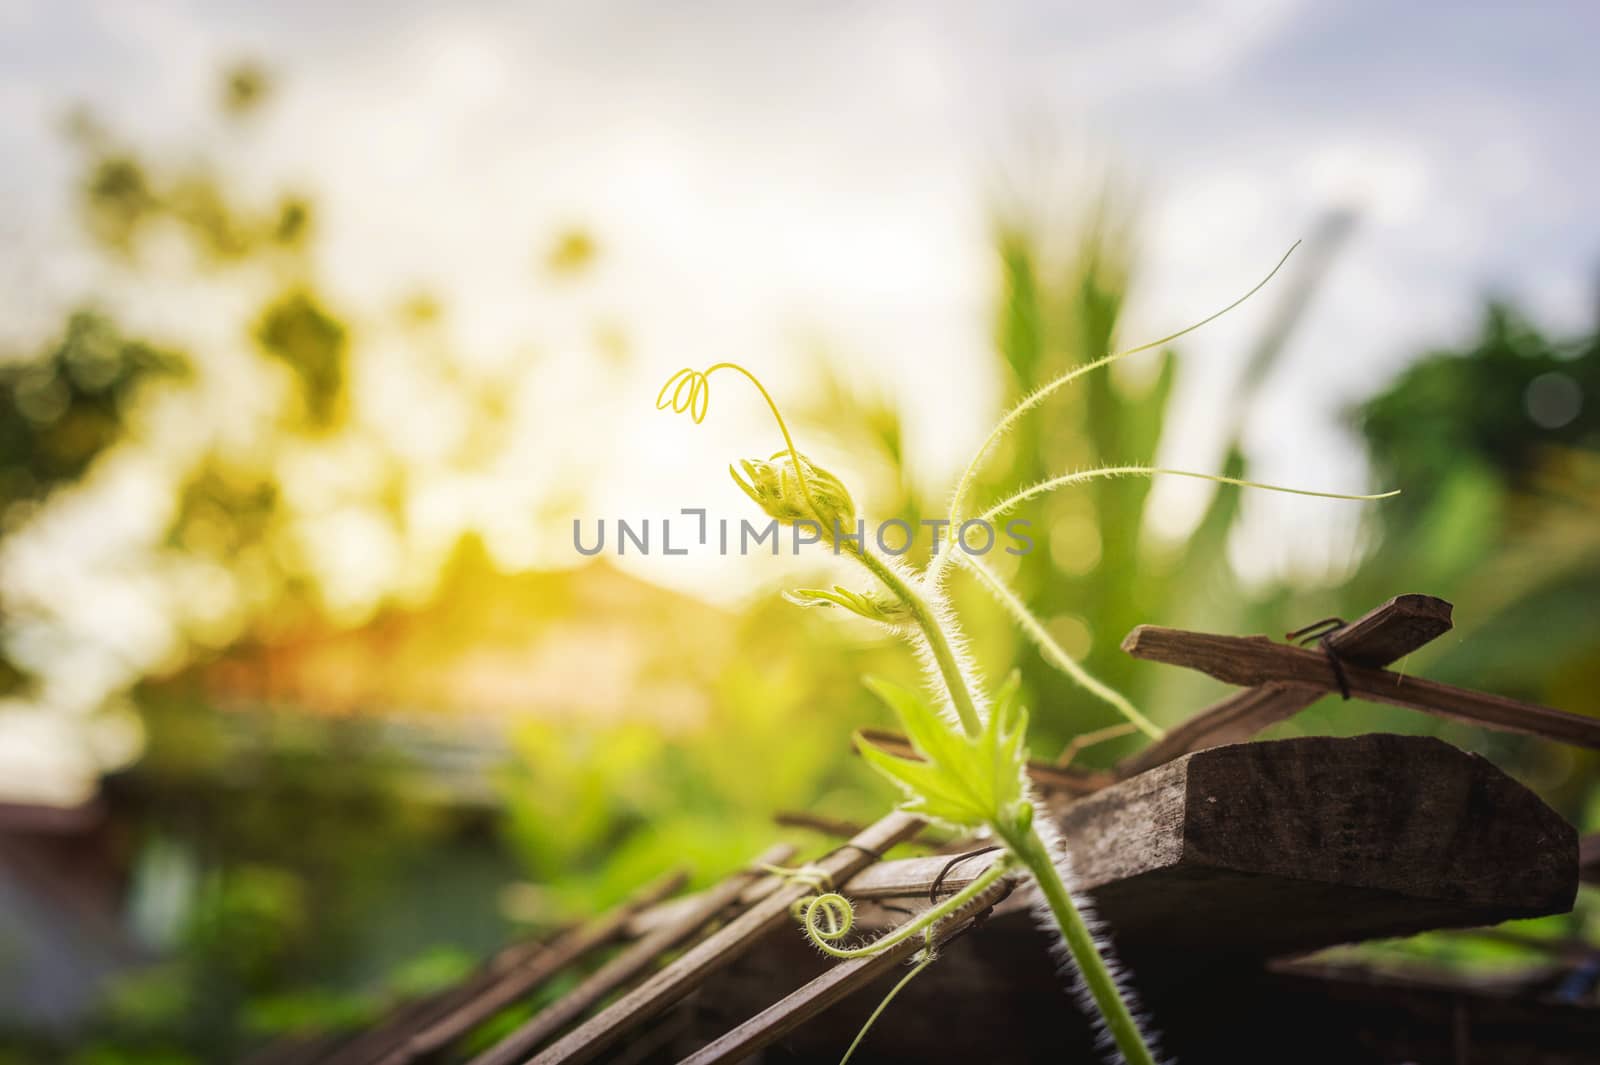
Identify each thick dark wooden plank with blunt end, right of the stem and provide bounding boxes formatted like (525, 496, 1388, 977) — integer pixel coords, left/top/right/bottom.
(1059, 734, 1578, 955)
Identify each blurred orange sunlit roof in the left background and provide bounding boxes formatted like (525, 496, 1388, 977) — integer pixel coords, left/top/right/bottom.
(146, 540, 736, 726)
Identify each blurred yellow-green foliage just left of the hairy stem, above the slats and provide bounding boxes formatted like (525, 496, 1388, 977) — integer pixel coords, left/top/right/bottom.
(504, 596, 917, 923)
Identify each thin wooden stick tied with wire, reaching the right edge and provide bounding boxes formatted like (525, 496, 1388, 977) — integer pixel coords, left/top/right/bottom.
(1122, 625, 1600, 748)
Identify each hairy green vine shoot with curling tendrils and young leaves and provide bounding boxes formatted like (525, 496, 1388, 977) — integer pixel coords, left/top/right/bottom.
(656, 248, 1395, 1065)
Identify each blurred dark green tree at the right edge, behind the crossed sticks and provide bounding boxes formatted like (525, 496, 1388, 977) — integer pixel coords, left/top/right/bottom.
(1342, 302, 1600, 812)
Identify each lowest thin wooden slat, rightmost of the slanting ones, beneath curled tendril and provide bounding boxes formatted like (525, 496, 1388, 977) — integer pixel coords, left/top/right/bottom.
(678, 881, 1011, 1065)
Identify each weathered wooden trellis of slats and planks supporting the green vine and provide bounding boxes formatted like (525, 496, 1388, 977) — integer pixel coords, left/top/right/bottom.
(256, 595, 1600, 1065)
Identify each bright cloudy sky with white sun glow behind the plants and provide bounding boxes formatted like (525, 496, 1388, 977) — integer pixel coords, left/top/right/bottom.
(0, 0, 1600, 796)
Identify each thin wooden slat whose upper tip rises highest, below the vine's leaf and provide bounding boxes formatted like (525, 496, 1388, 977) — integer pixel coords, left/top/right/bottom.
(533, 814, 922, 1065)
